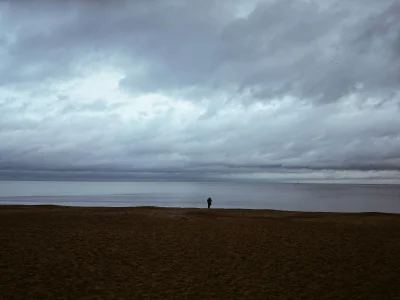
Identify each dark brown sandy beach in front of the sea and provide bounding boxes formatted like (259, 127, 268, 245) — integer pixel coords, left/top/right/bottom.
(0, 206, 400, 300)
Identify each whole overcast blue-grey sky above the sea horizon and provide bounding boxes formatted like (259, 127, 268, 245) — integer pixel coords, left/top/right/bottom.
(0, 0, 400, 183)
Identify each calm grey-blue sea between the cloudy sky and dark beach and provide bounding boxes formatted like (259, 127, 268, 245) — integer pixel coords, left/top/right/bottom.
(0, 181, 400, 213)
